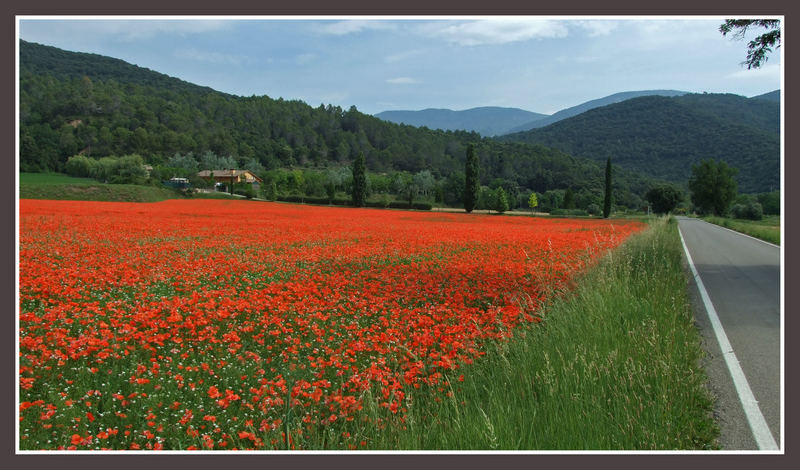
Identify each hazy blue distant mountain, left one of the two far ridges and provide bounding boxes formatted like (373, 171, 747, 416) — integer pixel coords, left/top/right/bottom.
(375, 106, 547, 137)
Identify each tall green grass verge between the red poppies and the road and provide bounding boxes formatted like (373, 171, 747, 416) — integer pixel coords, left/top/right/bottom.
(356, 219, 718, 450)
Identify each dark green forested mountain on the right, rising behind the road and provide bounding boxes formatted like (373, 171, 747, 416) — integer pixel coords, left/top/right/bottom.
(499, 94, 780, 192)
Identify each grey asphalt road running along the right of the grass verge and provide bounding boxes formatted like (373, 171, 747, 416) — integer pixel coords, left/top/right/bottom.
(678, 217, 782, 450)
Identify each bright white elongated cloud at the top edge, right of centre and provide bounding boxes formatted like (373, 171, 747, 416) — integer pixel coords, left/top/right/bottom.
(425, 19, 568, 46)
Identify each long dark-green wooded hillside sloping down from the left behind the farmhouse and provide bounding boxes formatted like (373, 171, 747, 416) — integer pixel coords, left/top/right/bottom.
(19, 41, 649, 207)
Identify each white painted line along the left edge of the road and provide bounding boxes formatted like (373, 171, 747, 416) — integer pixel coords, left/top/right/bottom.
(678, 227, 780, 450)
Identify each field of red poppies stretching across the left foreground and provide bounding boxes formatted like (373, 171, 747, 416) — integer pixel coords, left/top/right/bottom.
(19, 200, 643, 450)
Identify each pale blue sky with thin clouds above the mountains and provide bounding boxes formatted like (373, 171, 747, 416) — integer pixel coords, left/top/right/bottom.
(17, 16, 783, 114)
